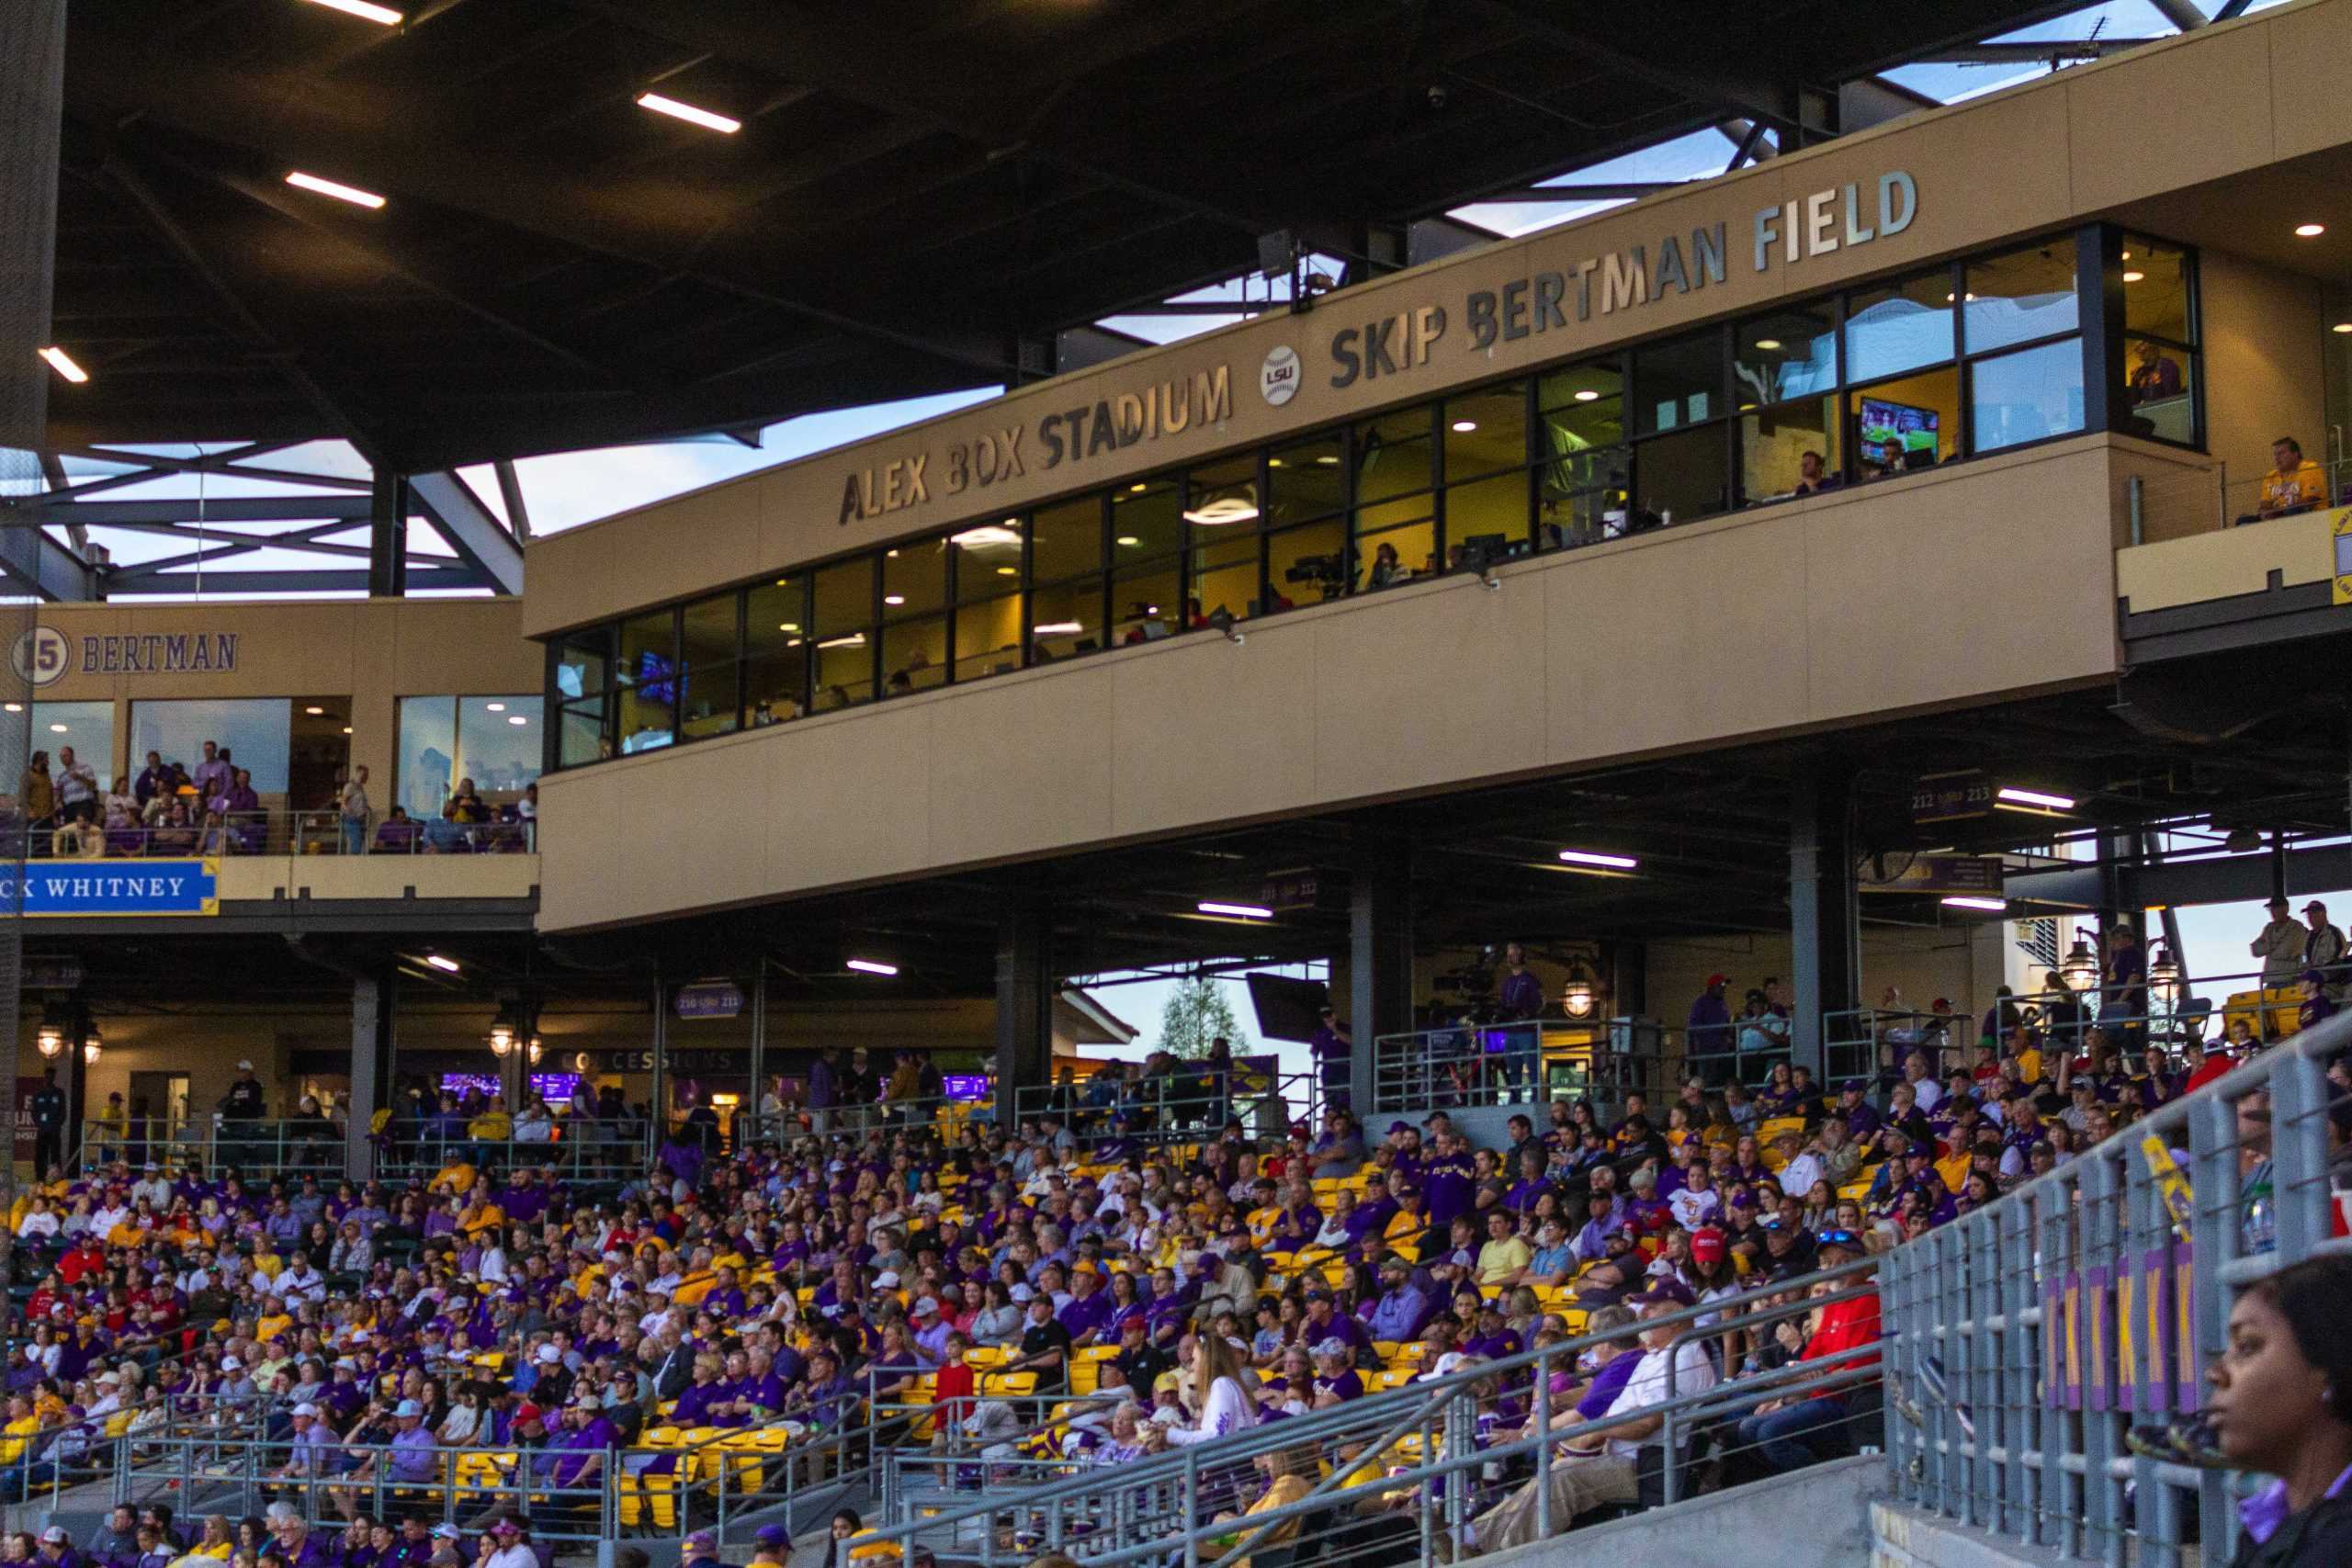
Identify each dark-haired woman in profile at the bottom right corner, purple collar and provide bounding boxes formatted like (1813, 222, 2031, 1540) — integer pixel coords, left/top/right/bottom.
(2206, 1258, 2352, 1568)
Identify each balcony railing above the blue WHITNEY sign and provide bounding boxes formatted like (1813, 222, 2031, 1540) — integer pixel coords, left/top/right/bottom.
(26, 808, 538, 861)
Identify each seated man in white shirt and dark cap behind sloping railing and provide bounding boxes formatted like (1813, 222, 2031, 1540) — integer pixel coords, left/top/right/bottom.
(1461, 1288, 1717, 1556)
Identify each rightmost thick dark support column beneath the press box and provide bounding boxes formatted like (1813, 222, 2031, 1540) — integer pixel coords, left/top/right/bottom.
(1788, 757, 1863, 1084)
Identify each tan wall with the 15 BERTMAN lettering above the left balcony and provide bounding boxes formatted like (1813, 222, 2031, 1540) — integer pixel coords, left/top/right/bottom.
(33, 600, 548, 811)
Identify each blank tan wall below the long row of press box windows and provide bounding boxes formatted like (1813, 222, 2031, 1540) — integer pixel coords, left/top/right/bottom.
(541, 434, 2117, 929)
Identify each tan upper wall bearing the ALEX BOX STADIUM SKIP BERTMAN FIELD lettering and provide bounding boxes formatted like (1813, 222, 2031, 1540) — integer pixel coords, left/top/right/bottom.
(526, 0, 2352, 637)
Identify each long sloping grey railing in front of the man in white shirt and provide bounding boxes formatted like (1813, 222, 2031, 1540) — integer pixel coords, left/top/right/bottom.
(870, 1258, 1879, 1568)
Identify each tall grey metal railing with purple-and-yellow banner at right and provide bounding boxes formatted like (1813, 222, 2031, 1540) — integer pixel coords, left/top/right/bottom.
(1882, 1016, 2352, 1568)
